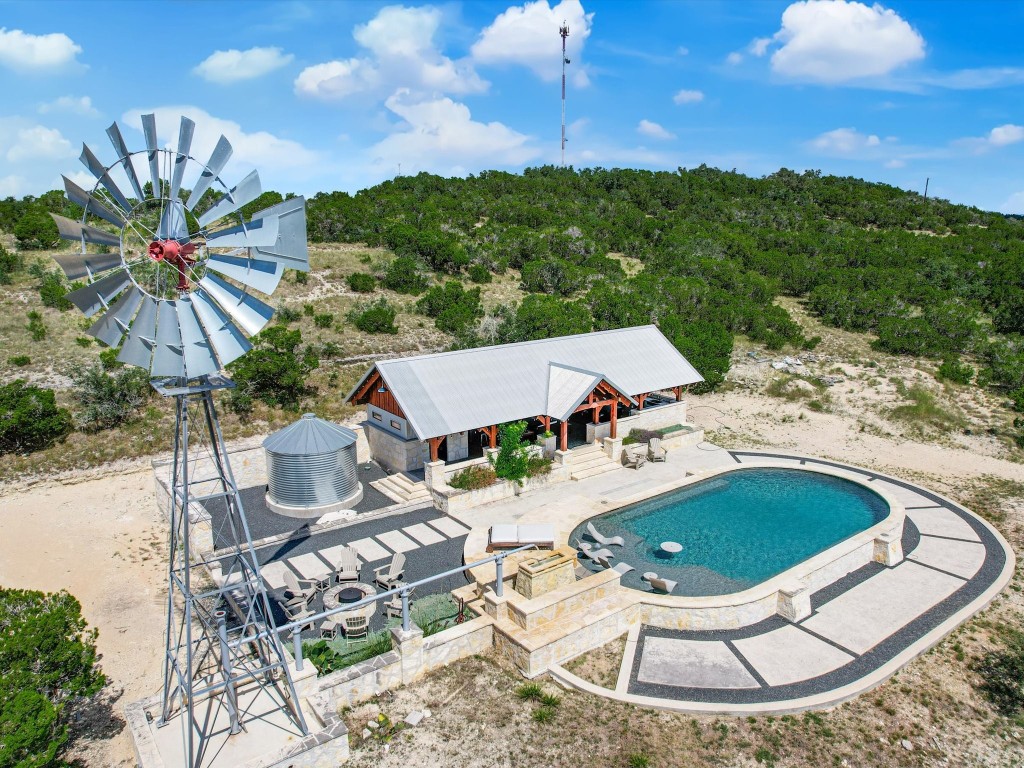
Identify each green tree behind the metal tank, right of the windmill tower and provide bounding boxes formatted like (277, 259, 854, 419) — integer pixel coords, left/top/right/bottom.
(227, 326, 319, 413)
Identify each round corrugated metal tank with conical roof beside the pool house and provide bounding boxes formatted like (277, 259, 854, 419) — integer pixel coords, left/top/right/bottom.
(263, 414, 359, 507)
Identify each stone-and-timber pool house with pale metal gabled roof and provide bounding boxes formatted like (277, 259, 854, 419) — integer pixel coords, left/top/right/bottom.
(346, 326, 703, 471)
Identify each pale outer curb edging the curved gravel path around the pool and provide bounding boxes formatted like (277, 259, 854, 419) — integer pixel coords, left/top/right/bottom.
(549, 451, 1016, 716)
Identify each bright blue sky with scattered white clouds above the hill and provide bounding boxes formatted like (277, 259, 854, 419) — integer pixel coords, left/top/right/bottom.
(0, 0, 1024, 213)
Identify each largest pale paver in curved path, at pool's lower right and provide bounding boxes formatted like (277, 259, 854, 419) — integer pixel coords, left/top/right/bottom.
(801, 561, 964, 654)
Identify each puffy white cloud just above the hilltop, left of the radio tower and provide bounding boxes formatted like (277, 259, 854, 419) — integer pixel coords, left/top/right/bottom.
(368, 88, 540, 174)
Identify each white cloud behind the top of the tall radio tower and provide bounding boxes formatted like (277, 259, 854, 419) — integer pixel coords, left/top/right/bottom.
(472, 0, 594, 87)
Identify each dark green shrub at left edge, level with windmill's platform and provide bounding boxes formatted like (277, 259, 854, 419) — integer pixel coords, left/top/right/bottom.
(0, 379, 73, 454)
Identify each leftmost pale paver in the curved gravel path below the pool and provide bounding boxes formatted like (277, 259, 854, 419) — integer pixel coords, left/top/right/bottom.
(637, 637, 760, 688)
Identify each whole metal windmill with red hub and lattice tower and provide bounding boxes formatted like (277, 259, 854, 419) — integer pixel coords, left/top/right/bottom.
(53, 115, 309, 768)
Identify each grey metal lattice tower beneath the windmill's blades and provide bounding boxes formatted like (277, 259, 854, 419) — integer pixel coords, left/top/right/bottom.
(154, 378, 308, 768)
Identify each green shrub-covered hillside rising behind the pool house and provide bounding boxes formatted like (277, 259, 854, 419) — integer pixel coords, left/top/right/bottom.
(0, 167, 1024, 479)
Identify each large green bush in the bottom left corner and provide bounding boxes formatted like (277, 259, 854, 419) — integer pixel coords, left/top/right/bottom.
(0, 588, 106, 768)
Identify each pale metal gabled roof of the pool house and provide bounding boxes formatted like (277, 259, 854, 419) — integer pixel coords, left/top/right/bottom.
(346, 326, 703, 439)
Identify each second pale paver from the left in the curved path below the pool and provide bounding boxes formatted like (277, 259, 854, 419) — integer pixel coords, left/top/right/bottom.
(733, 625, 854, 685)
